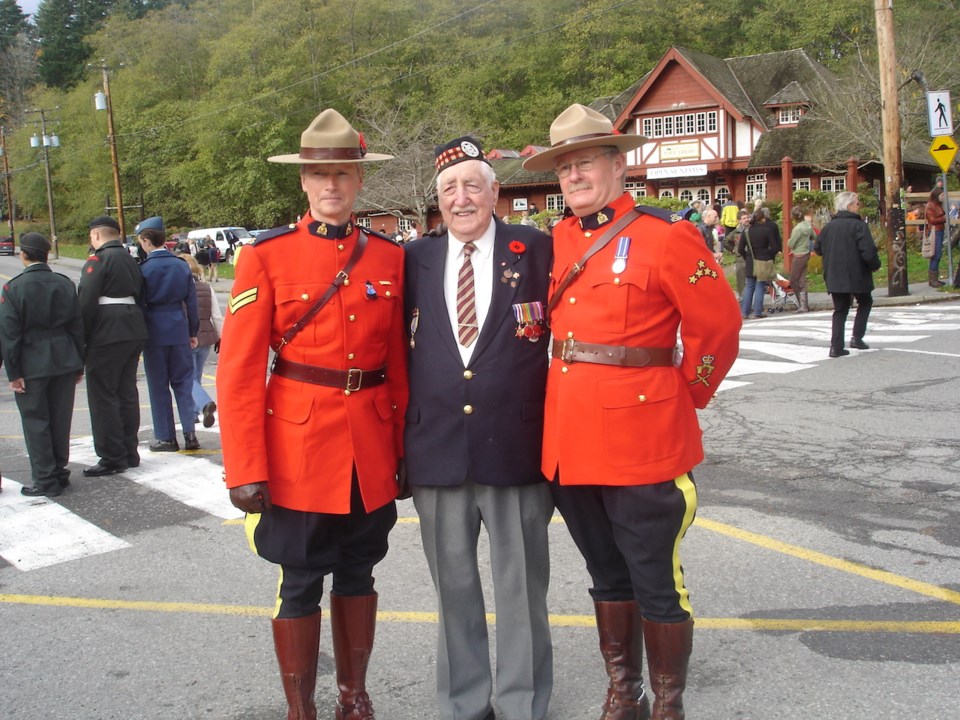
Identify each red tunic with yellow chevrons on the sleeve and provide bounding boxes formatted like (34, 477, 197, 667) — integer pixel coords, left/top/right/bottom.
(217, 213, 407, 514)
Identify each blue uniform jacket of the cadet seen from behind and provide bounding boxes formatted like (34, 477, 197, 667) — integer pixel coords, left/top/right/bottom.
(140, 250, 200, 345)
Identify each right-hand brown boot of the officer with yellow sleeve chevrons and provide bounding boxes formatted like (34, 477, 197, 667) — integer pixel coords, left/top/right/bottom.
(330, 593, 377, 720)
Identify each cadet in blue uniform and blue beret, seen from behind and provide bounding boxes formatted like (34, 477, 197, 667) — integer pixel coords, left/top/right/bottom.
(136, 217, 200, 452)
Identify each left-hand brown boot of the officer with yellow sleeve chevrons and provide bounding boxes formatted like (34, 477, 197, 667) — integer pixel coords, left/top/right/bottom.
(273, 612, 320, 720)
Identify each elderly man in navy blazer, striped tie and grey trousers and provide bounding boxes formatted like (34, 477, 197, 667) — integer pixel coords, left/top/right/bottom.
(404, 137, 553, 720)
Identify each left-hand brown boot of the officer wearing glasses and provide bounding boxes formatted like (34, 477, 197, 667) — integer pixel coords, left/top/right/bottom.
(593, 600, 650, 720)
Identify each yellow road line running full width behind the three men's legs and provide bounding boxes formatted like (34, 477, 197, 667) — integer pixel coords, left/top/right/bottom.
(0, 594, 960, 635)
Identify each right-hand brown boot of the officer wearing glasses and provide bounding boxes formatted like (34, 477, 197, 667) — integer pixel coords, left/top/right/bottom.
(643, 618, 693, 720)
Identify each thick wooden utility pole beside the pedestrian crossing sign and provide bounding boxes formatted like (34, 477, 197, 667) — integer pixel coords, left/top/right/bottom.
(874, 0, 910, 297)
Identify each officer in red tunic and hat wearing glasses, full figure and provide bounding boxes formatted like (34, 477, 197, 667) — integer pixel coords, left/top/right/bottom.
(524, 104, 740, 720)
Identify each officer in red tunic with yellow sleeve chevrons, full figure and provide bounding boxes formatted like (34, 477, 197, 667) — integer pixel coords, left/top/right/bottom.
(217, 110, 407, 720)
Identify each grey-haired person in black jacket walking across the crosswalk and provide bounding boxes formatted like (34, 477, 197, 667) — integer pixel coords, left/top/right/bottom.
(814, 191, 880, 357)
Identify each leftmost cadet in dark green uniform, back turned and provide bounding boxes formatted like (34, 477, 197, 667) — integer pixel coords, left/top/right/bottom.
(0, 233, 83, 497)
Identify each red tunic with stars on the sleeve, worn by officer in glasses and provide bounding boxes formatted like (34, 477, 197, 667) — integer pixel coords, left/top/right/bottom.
(542, 194, 741, 485)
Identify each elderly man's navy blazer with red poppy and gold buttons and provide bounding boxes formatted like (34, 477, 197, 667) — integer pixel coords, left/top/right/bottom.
(404, 220, 553, 486)
